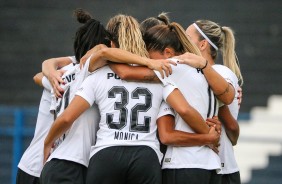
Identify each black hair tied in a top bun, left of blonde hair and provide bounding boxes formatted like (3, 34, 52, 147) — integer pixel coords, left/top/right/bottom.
(73, 9, 110, 62)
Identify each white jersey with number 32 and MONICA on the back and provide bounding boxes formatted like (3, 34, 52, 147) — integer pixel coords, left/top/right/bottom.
(77, 66, 163, 161)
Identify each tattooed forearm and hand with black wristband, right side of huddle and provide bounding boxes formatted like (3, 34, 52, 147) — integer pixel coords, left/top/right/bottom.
(174, 52, 235, 105)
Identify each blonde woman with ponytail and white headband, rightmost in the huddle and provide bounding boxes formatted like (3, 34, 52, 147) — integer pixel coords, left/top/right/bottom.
(184, 20, 243, 184)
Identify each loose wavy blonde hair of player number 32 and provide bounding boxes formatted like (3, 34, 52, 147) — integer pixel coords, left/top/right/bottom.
(107, 14, 149, 57)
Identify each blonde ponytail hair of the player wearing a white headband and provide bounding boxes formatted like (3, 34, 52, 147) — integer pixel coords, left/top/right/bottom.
(195, 20, 244, 86)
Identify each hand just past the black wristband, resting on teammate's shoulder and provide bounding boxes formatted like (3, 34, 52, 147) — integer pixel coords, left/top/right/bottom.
(173, 52, 206, 68)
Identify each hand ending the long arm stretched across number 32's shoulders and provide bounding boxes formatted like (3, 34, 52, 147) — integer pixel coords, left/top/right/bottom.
(147, 59, 177, 78)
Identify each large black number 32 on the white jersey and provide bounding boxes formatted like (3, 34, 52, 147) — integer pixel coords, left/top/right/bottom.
(106, 86, 152, 132)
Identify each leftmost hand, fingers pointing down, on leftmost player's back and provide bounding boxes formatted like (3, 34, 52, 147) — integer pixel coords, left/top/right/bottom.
(48, 70, 66, 98)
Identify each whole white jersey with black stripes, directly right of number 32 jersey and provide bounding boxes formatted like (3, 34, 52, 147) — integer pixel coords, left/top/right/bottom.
(156, 59, 221, 172)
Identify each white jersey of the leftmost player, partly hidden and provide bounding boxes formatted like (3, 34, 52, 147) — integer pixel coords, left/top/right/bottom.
(18, 88, 54, 177)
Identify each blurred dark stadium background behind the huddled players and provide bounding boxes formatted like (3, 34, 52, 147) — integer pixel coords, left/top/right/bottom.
(0, 0, 282, 184)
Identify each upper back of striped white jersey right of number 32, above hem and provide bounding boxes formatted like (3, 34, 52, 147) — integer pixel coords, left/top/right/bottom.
(156, 61, 218, 132)
